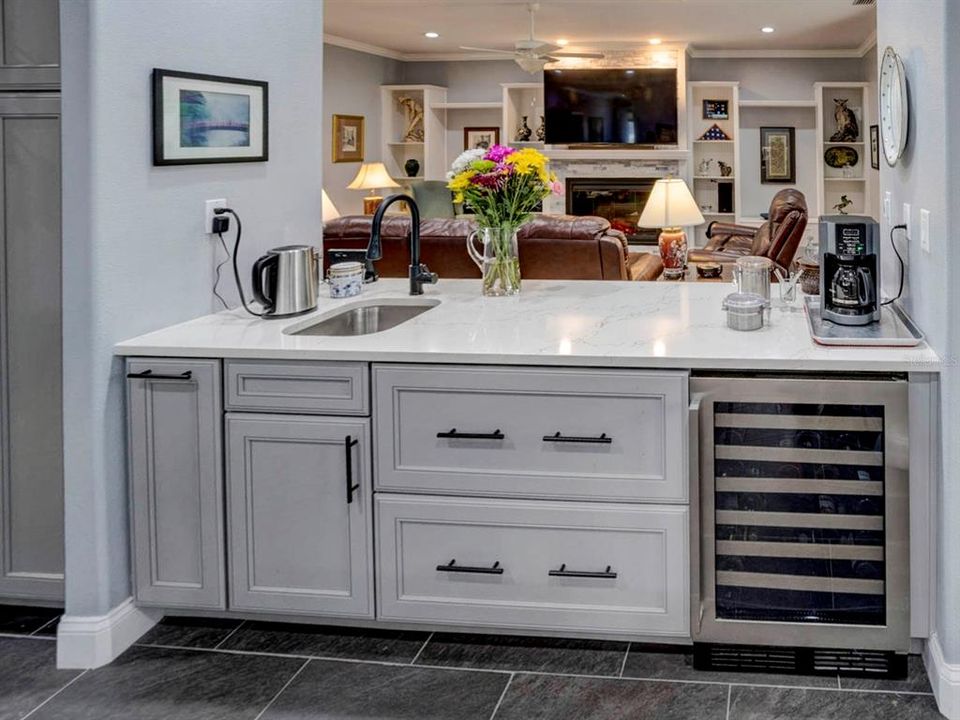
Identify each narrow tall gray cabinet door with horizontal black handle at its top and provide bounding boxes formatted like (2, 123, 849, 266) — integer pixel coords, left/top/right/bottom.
(127, 359, 226, 609)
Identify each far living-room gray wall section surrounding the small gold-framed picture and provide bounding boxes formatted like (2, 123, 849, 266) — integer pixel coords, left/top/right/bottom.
(323, 45, 402, 215)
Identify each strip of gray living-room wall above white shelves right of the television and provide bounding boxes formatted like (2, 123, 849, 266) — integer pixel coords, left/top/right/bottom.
(687, 58, 866, 100)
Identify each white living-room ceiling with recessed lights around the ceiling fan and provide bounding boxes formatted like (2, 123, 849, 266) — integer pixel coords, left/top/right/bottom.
(324, 0, 876, 60)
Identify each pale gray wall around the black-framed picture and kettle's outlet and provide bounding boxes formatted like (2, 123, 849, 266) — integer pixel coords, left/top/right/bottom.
(61, 0, 326, 615)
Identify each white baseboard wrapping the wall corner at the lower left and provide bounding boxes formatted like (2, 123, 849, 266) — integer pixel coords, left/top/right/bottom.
(57, 598, 163, 669)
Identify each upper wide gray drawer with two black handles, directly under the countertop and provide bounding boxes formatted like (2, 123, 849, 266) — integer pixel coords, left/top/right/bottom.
(373, 365, 687, 502)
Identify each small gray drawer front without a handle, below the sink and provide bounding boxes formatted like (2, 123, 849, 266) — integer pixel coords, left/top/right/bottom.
(226, 360, 370, 415)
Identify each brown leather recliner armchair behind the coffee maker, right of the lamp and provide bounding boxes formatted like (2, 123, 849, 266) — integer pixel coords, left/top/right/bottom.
(687, 188, 807, 270)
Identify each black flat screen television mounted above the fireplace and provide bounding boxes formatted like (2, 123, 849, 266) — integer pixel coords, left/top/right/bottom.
(543, 68, 677, 145)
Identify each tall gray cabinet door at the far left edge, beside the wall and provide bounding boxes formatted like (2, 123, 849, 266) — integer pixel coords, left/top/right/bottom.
(0, 94, 63, 601)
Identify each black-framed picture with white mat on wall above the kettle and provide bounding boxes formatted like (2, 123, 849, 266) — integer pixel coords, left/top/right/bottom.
(152, 68, 269, 165)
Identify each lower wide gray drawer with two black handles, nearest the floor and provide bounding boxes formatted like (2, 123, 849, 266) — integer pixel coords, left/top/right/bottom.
(376, 494, 689, 637)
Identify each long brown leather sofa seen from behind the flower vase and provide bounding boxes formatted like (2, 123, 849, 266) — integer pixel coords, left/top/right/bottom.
(323, 215, 663, 280)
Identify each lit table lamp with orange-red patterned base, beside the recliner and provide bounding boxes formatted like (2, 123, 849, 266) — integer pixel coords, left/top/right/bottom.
(637, 177, 703, 278)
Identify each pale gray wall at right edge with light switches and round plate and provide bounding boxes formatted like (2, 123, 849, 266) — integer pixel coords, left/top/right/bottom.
(877, 0, 960, 663)
